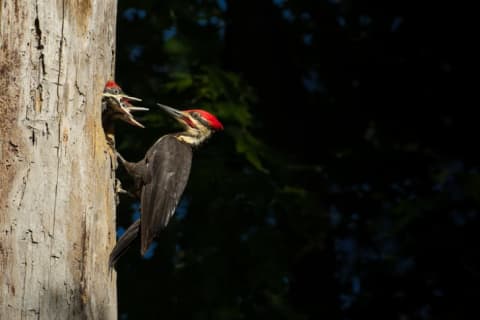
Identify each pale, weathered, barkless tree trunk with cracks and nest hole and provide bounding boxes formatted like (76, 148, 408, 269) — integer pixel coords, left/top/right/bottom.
(0, 0, 117, 320)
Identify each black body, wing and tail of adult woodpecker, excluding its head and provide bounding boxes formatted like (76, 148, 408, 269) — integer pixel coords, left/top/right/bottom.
(110, 135, 193, 266)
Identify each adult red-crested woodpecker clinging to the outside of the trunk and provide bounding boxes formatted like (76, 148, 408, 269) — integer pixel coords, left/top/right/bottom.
(109, 104, 223, 267)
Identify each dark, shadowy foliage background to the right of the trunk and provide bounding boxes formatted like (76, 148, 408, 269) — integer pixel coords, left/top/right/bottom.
(111, 0, 480, 320)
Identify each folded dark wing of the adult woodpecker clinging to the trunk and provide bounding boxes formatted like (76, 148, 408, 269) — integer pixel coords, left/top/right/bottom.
(140, 135, 192, 255)
